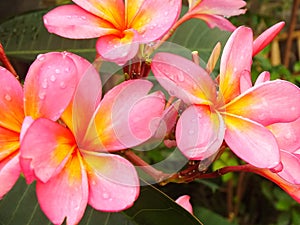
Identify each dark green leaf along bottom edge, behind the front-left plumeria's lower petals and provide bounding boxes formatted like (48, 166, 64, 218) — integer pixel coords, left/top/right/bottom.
(0, 178, 201, 225)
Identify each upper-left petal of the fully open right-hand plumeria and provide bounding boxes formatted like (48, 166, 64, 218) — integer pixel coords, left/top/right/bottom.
(151, 53, 216, 104)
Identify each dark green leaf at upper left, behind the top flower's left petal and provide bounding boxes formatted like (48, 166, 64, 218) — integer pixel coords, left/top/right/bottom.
(0, 10, 96, 61)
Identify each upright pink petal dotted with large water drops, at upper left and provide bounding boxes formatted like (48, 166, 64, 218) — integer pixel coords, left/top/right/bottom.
(24, 52, 78, 120)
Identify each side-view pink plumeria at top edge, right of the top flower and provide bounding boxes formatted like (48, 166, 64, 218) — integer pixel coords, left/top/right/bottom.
(183, 0, 246, 31)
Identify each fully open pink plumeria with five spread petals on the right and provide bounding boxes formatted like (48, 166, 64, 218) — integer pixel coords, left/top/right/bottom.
(152, 27, 300, 168)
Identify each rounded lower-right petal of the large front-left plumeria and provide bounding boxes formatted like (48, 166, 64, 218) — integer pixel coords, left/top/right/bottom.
(83, 152, 139, 212)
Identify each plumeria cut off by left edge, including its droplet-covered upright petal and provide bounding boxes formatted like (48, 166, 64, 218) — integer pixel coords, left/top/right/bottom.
(0, 52, 87, 198)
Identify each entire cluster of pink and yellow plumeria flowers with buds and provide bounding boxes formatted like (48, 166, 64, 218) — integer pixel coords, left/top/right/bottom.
(0, 0, 300, 224)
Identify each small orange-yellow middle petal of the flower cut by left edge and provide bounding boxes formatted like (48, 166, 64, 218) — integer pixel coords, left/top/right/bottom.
(0, 127, 20, 162)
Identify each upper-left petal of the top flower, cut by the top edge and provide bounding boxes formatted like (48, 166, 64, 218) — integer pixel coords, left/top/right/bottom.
(72, 0, 126, 30)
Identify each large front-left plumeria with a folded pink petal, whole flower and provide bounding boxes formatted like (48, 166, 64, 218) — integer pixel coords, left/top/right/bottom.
(20, 67, 165, 225)
